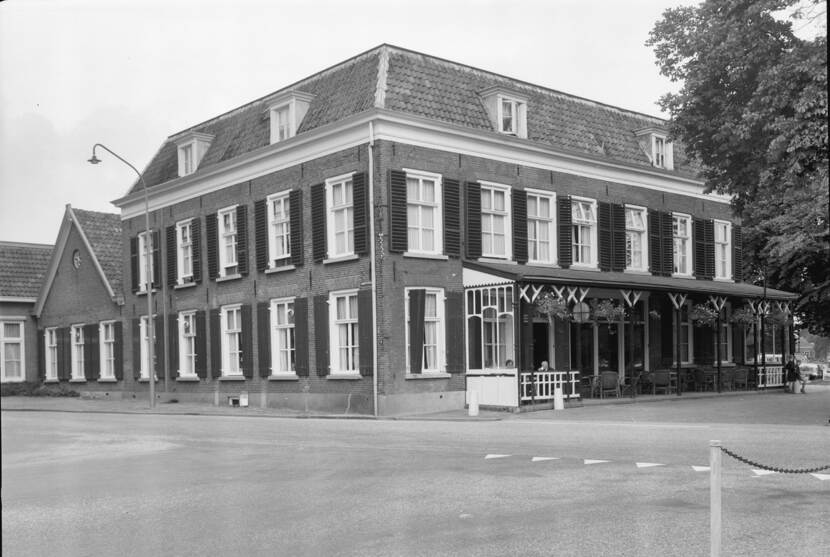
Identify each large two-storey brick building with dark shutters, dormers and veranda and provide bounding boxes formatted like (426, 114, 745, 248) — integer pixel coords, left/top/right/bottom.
(107, 45, 793, 414)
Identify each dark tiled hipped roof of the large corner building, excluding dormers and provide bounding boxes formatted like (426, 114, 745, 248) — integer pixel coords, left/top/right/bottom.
(133, 45, 698, 191)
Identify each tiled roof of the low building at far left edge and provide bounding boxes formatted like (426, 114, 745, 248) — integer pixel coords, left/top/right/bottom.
(0, 242, 53, 298)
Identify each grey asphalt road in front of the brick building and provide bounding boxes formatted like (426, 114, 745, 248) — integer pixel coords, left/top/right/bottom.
(2, 387, 830, 557)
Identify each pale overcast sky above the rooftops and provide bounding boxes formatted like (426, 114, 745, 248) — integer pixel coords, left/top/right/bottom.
(0, 0, 696, 244)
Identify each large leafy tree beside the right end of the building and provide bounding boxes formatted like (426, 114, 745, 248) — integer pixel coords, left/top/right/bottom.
(646, 0, 830, 334)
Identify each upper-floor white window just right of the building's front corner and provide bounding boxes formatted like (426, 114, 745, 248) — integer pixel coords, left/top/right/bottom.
(406, 170, 443, 254)
